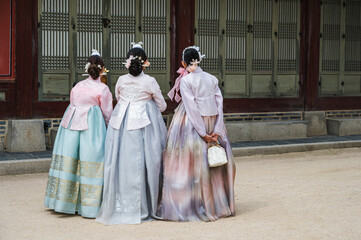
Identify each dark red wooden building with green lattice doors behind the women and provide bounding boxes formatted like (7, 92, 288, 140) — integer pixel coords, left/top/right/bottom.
(0, 0, 361, 119)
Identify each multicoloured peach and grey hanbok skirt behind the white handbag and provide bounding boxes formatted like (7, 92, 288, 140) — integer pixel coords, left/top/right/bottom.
(157, 103, 235, 221)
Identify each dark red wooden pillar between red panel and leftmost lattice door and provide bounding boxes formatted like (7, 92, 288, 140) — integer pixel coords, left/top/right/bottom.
(15, 0, 37, 118)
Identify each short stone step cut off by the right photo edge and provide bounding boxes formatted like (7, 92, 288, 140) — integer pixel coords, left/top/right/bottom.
(326, 118, 361, 136)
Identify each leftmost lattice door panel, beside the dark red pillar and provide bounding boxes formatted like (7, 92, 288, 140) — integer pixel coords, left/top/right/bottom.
(38, 0, 71, 100)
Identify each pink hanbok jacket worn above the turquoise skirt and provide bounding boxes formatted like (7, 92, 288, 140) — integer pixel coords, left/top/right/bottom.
(61, 77, 113, 131)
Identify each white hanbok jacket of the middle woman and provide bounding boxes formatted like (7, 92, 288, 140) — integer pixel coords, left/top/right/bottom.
(109, 72, 167, 130)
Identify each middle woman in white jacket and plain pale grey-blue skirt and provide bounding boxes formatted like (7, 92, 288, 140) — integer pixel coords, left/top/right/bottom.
(96, 43, 167, 225)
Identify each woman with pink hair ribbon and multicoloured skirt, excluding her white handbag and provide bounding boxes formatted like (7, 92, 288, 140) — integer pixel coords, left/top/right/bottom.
(157, 46, 235, 221)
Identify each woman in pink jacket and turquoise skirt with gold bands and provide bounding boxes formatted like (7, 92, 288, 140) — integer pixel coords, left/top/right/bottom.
(44, 50, 113, 218)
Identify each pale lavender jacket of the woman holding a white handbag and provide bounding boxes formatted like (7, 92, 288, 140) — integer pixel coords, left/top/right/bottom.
(180, 67, 224, 137)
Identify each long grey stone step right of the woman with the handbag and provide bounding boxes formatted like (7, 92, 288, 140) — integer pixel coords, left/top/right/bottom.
(226, 120, 307, 143)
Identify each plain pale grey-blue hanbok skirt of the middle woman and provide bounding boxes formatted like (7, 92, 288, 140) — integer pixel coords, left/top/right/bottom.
(96, 100, 167, 225)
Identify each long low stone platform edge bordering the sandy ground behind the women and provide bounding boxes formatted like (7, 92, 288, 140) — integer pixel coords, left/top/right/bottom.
(0, 140, 361, 176)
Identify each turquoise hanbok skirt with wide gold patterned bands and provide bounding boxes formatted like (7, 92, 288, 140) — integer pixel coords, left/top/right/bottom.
(44, 106, 106, 218)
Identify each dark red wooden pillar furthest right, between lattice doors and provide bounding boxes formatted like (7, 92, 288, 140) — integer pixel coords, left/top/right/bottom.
(303, 0, 321, 111)
